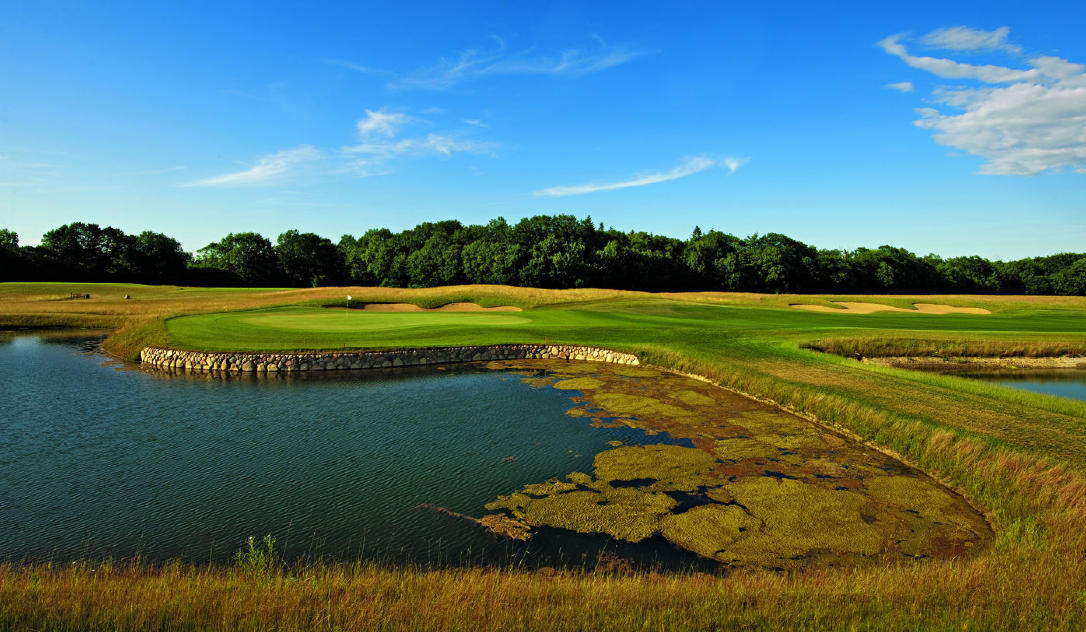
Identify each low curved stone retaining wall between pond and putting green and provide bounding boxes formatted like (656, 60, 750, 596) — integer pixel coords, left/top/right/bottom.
(140, 344, 640, 372)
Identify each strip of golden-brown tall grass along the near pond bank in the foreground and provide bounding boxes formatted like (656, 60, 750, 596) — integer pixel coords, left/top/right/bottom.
(0, 558, 1086, 632)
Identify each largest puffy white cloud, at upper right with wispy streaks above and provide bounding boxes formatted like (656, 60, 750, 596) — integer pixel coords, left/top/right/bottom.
(879, 27, 1086, 176)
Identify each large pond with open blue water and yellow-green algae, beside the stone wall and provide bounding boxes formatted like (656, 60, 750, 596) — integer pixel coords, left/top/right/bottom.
(0, 333, 990, 568)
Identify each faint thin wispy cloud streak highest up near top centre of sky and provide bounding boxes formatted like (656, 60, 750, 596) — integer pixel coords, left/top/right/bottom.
(389, 36, 647, 90)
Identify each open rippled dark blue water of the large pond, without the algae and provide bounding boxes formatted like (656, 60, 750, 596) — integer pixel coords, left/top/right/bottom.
(0, 334, 670, 564)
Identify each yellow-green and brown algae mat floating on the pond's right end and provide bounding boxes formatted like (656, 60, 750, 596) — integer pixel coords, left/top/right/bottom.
(483, 362, 992, 569)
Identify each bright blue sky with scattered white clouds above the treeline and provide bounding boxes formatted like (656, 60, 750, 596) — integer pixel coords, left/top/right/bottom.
(0, 1, 1086, 260)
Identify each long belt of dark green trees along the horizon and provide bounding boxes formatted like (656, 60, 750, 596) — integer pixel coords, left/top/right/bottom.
(0, 215, 1086, 295)
